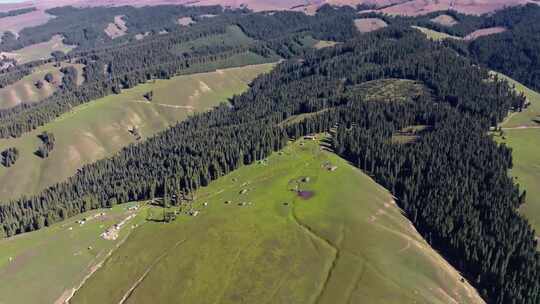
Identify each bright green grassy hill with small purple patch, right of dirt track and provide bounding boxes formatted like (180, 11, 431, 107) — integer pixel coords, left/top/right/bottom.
(71, 141, 481, 303)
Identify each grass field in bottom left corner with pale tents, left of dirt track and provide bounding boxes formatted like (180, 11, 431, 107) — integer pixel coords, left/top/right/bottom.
(0, 205, 145, 304)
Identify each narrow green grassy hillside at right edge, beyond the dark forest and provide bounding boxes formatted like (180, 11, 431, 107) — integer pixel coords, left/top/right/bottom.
(496, 74, 540, 234)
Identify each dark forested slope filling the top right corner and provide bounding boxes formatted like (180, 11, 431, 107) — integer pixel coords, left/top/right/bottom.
(360, 3, 540, 90)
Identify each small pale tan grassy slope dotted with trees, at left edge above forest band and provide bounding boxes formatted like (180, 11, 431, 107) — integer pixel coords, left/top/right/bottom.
(0, 63, 83, 109)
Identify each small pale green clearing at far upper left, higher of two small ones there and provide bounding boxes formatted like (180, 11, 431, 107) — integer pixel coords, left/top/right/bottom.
(2, 35, 75, 64)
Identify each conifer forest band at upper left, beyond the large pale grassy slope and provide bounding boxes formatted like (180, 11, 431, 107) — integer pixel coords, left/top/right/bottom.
(0, 7, 355, 138)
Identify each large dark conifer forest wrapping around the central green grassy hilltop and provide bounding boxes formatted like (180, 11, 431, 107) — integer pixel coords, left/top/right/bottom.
(0, 28, 540, 303)
